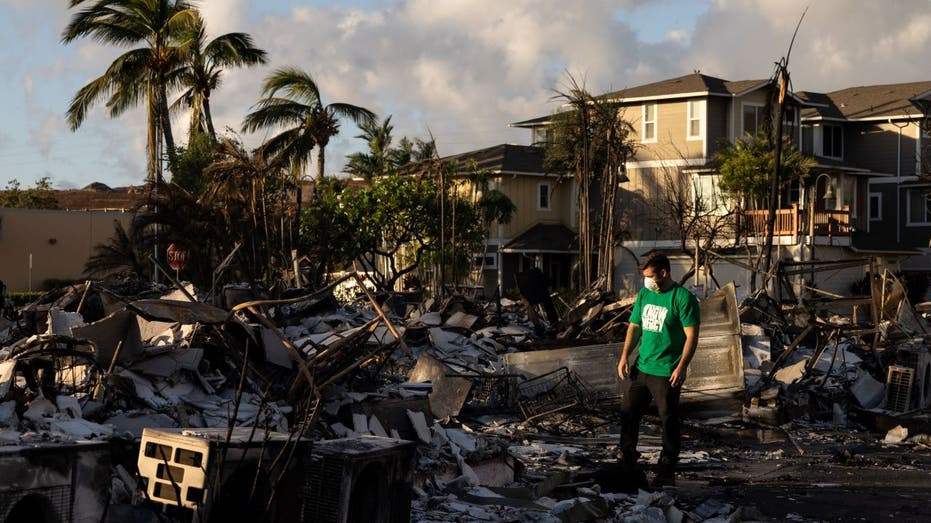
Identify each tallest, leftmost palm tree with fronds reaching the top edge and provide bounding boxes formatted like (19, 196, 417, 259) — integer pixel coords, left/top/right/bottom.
(62, 0, 196, 181)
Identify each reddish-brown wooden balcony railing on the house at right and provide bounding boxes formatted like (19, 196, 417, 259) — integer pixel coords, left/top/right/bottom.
(738, 204, 853, 243)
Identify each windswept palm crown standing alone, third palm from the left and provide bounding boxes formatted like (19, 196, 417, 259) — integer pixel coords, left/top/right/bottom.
(243, 67, 375, 186)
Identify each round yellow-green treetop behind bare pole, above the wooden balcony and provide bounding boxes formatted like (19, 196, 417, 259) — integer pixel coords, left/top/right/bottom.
(714, 133, 814, 209)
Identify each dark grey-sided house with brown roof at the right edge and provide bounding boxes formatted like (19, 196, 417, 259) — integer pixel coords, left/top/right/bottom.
(799, 82, 931, 258)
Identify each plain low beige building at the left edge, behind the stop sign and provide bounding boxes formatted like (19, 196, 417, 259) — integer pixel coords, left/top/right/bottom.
(0, 208, 133, 291)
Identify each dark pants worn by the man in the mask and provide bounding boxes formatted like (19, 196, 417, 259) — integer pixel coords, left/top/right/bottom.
(621, 368, 682, 464)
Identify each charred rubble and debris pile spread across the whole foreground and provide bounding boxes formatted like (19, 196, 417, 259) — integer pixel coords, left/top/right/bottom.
(0, 268, 931, 522)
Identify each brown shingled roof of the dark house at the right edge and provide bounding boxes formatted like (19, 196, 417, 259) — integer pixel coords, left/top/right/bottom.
(801, 82, 931, 120)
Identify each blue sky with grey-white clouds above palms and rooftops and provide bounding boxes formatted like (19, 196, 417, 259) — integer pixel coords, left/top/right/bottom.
(0, 0, 931, 188)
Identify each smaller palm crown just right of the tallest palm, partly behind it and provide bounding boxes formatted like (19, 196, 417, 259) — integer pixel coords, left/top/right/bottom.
(172, 13, 266, 140)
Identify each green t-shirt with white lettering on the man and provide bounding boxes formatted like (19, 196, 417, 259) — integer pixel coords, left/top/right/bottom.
(630, 284, 701, 376)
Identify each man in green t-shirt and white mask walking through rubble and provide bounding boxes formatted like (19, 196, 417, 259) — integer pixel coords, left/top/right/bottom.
(617, 253, 701, 487)
